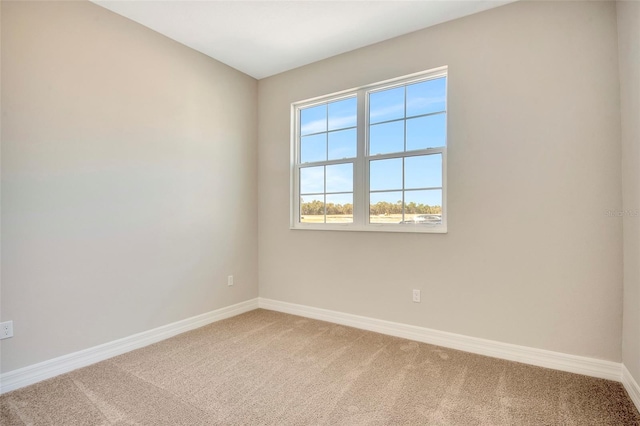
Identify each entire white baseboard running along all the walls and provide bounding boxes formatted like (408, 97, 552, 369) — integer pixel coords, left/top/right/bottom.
(0, 298, 628, 396)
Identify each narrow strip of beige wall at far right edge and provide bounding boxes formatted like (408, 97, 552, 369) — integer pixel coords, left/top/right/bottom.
(617, 1, 640, 383)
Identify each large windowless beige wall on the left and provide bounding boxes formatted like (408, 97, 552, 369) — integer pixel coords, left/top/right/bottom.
(1, 1, 258, 372)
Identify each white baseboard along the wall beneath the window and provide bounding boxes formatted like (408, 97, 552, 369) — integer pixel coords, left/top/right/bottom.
(258, 298, 624, 382)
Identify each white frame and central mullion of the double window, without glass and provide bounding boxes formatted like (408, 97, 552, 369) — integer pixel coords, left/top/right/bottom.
(290, 66, 449, 233)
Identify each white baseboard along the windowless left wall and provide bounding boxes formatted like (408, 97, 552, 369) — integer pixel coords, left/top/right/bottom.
(0, 298, 258, 394)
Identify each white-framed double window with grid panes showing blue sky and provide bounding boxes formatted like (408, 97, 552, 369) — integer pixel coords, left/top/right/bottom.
(291, 67, 447, 233)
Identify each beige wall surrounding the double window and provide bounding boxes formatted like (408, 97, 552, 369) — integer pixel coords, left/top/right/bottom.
(258, 2, 622, 361)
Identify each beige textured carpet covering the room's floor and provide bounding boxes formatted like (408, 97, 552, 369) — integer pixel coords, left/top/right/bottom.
(0, 310, 640, 426)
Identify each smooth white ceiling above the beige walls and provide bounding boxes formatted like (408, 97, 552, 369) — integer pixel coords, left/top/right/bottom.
(92, 0, 515, 79)
